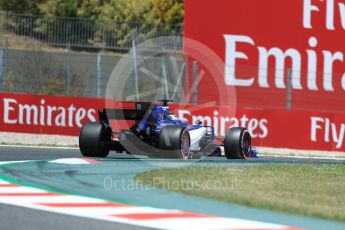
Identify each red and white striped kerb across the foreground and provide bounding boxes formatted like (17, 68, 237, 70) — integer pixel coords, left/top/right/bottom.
(0, 180, 296, 230)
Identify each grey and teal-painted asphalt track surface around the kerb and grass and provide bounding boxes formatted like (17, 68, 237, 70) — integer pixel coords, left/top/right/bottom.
(0, 146, 345, 230)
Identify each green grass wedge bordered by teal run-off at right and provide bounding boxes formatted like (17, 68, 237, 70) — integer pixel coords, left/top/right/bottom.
(135, 164, 345, 222)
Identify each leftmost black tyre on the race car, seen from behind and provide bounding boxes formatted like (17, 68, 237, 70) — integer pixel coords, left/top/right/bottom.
(79, 122, 111, 157)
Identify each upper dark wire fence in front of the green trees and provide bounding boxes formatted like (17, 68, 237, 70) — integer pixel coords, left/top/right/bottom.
(0, 12, 183, 50)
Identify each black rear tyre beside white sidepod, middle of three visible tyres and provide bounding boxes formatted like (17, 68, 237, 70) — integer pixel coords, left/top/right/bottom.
(158, 125, 190, 159)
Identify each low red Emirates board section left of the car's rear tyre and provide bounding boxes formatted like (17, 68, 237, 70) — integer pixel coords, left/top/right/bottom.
(0, 94, 105, 135)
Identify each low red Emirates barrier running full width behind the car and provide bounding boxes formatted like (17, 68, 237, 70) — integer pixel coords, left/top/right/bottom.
(0, 94, 345, 151)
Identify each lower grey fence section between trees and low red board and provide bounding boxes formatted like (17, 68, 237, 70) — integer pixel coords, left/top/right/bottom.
(0, 38, 186, 102)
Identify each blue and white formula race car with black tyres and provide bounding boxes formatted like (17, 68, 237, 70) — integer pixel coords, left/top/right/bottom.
(79, 99, 252, 159)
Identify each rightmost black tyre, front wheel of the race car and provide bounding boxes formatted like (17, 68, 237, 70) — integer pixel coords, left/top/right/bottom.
(224, 127, 252, 159)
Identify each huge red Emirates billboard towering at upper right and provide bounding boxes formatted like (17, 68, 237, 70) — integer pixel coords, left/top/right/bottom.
(184, 0, 345, 112)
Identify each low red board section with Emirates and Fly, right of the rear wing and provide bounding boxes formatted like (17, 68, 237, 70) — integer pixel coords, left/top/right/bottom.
(175, 106, 345, 152)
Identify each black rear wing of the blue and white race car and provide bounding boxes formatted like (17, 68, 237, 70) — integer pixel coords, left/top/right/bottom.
(98, 102, 152, 124)
